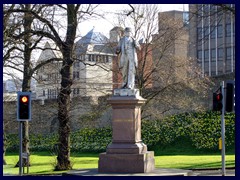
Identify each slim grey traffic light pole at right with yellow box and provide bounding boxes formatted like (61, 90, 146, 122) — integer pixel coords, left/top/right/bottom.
(221, 81, 226, 176)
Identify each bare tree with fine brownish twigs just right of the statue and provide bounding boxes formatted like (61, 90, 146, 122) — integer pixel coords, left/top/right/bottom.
(113, 4, 209, 117)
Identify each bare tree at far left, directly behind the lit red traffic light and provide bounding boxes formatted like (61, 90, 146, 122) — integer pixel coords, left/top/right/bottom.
(3, 4, 45, 166)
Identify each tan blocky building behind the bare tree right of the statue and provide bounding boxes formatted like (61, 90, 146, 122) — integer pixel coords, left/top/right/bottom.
(152, 10, 189, 88)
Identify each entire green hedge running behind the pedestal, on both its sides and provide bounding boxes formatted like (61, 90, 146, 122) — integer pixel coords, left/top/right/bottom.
(6, 111, 235, 153)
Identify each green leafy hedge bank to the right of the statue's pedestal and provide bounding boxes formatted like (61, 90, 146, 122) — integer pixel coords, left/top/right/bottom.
(142, 111, 235, 150)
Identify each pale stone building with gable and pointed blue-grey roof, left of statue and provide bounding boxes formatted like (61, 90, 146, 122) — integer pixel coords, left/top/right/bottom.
(36, 29, 115, 99)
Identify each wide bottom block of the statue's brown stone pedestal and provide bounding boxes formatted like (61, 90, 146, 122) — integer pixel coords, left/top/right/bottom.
(98, 151, 155, 173)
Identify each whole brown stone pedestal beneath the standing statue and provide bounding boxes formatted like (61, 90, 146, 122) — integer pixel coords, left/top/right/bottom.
(98, 89, 155, 173)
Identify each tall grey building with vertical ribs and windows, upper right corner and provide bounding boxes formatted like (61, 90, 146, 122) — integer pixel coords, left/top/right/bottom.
(189, 4, 235, 77)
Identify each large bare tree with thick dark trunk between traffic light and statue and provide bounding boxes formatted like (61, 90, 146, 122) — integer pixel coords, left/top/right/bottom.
(3, 4, 97, 170)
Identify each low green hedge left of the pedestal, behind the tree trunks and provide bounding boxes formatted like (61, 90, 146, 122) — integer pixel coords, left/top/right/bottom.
(6, 127, 112, 154)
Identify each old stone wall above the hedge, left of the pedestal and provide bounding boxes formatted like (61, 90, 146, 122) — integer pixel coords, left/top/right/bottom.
(3, 97, 111, 134)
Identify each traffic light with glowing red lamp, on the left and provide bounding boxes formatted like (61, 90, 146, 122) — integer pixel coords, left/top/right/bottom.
(17, 92, 31, 121)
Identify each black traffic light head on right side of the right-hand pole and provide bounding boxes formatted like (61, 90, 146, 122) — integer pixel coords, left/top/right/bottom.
(225, 83, 234, 112)
